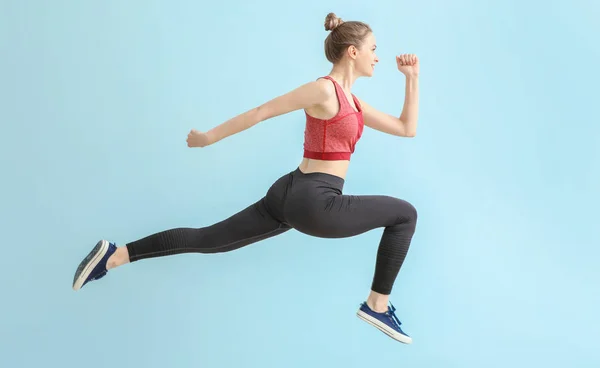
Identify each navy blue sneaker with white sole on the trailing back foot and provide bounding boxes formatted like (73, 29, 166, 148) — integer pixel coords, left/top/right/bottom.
(73, 240, 117, 290)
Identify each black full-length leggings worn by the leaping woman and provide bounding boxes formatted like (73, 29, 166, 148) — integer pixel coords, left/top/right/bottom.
(126, 169, 417, 295)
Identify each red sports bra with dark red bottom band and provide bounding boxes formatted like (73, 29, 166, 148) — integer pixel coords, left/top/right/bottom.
(304, 76, 364, 161)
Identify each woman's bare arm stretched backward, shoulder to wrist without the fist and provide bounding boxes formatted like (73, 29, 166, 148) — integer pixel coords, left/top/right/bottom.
(199, 79, 335, 145)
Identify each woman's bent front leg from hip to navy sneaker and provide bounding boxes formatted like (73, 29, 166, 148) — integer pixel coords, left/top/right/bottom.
(285, 171, 417, 343)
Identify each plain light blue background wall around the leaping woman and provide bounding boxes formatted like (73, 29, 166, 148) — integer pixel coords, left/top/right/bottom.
(0, 0, 600, 368)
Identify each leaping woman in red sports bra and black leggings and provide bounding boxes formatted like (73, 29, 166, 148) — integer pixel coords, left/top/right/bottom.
(73, 13, 419, 343)
